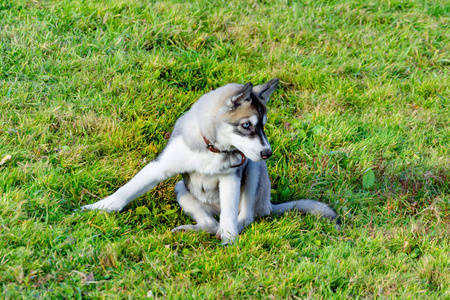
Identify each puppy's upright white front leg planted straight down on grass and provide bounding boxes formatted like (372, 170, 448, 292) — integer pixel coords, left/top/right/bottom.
(217, 174, 241, 244)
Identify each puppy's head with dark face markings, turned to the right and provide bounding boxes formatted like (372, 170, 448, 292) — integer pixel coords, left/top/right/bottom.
(216, 78, 279, 161)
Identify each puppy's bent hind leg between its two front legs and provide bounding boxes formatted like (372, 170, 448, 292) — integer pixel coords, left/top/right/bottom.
(172, 181, 219, 234)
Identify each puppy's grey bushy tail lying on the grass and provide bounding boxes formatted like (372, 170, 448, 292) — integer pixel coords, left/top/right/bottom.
(272, 199, 341, 228)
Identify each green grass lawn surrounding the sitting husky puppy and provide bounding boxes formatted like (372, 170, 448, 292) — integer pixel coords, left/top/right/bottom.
(0, 0, 450, 299)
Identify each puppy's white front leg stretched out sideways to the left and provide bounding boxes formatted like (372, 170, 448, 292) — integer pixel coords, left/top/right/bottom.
(82, 139, 190, 212)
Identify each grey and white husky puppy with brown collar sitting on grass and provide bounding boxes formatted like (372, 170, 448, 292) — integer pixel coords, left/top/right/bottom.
(82, 78, 337, 244)
